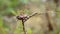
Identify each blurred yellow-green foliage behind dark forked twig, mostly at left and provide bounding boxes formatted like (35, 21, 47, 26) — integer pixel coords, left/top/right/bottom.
(0, 0, 60, 34)
